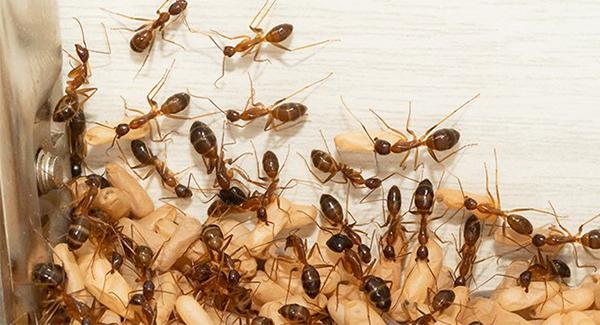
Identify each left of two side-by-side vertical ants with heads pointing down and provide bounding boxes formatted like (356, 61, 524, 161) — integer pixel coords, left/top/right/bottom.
(381, 185, 408, 261)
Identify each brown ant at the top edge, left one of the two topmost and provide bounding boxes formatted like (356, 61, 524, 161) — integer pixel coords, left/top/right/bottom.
(101, 0, 201, 77)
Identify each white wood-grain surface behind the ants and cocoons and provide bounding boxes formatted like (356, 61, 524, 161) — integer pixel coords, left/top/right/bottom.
(61, 0, 600, 287)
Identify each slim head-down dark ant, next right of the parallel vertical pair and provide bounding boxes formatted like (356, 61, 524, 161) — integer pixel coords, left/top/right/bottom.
(454, 214, 481, 287)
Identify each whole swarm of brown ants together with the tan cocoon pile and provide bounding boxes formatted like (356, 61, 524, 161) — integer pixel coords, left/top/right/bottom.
(27, 0, 600, 325)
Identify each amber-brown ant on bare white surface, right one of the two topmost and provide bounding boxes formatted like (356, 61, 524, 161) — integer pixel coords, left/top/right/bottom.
(207, 0, 332, 87)
